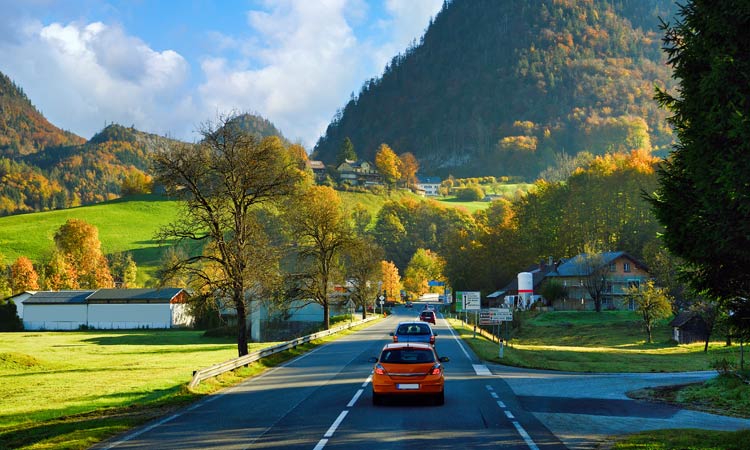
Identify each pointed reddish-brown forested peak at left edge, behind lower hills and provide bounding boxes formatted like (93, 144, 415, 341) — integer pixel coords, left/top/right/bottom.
(0, 72, 86, 158)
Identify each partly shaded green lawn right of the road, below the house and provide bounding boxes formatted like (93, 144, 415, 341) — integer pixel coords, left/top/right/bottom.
(453, 311, 739, 372)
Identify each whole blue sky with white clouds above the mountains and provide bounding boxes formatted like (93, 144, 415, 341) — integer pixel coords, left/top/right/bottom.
(0, 0, 443, 149)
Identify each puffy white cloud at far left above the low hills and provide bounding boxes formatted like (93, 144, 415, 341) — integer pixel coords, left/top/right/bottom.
(0, 16, 194, 138)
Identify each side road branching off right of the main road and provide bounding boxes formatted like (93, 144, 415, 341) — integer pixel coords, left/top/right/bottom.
(488, 364, 750, 449)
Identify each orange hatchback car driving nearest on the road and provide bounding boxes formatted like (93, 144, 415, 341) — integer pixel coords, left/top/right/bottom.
(372, 342, 448, 405)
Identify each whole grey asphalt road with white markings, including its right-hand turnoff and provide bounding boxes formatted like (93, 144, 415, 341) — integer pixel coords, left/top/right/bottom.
(97, 305, 750, 450)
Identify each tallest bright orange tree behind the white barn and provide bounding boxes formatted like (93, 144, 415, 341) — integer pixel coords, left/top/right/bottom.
(54, 219, 114, 289)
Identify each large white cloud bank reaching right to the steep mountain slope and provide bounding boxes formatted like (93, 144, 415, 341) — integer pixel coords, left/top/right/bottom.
(199, 0, 442, 148)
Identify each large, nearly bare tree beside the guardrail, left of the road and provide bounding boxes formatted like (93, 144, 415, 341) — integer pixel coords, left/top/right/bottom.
(154, 116, 305, 356)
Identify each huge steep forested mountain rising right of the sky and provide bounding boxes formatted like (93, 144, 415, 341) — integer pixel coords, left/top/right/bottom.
(313, 0, 676, 179)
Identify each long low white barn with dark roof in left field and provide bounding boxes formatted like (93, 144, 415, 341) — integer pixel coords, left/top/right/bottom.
(13, 288, 193, 330)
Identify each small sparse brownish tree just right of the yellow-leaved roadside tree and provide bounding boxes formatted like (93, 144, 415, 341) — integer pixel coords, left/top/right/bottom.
(345, 238, 383, 319)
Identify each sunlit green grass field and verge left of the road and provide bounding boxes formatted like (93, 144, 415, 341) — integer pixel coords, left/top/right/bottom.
(0, 316, 378, 450)
